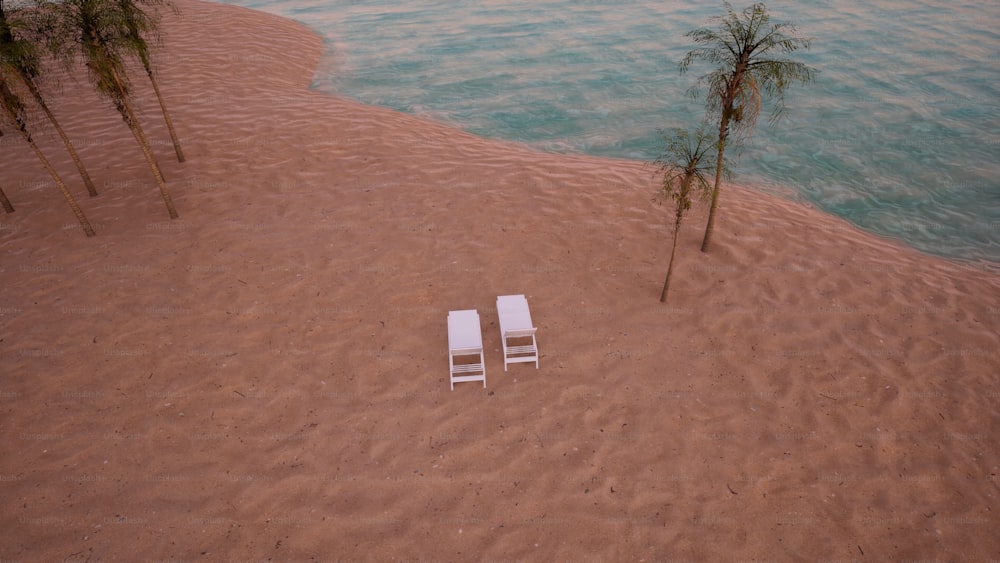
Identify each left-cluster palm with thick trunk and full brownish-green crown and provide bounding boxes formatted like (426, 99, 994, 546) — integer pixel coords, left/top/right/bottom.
(43, 0, 177, 219)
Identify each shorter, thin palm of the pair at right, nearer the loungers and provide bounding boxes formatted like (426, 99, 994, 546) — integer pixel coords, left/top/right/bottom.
(656, 127, 725, 303)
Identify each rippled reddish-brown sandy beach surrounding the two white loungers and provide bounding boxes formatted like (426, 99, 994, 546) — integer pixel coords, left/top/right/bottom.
(0, 0, 1000, 562)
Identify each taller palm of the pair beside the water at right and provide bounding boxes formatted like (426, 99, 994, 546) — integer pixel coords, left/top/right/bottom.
(680, 2, 816, 252)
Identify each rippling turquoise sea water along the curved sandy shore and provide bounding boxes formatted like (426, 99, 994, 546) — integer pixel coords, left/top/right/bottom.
(215, 0, 1000, 269)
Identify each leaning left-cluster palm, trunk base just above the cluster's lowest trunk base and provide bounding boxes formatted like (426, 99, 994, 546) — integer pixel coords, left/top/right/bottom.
(0, 0, 97, 197)
